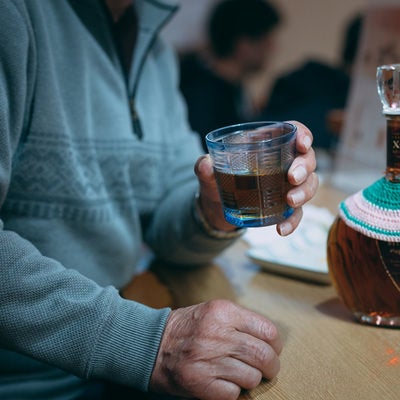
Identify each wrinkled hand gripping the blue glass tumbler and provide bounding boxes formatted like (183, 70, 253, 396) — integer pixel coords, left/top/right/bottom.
(194, 121, 318, 236)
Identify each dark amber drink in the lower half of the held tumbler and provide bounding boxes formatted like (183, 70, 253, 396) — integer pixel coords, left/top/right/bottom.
(215, 170, 292, 226)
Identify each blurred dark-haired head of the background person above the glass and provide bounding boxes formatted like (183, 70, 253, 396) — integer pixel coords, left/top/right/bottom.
(208, 0, 281, 74)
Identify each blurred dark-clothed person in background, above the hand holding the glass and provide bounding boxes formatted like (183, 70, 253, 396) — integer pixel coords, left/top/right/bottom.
(258, 15, 362, 152)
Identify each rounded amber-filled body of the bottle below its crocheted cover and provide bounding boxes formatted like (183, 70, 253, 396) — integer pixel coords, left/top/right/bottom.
(328, 218, 400, 327)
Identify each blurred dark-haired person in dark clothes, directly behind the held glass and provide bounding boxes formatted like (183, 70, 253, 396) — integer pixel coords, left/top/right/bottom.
(180, 0, 281, 151)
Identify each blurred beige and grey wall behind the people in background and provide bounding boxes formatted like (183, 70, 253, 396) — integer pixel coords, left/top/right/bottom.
(164, 0, 368, 104)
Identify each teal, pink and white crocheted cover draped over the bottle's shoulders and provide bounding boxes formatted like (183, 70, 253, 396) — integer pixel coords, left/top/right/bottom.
(339, 178, 400, 242)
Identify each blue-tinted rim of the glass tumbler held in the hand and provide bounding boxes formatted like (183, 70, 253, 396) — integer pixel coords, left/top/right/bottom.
(206, 121, 297, 148)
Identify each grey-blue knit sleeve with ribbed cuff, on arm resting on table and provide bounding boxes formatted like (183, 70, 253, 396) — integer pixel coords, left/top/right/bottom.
(0, 0, 170, 397)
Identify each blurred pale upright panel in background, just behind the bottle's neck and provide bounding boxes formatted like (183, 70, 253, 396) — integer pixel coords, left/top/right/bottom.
(331, 0, 400, 193)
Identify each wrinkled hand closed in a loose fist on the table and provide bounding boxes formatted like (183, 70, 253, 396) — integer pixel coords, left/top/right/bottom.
(150, 300, 282, 400)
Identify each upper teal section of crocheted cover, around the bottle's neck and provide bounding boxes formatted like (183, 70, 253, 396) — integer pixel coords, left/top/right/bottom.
(363, 178, 400, 210)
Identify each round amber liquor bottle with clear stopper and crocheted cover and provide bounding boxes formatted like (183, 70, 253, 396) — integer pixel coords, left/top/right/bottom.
(327, 64, 400, 328)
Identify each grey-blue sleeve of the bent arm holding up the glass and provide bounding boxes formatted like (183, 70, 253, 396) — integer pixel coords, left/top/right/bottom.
(145, 43, 239, 267)
